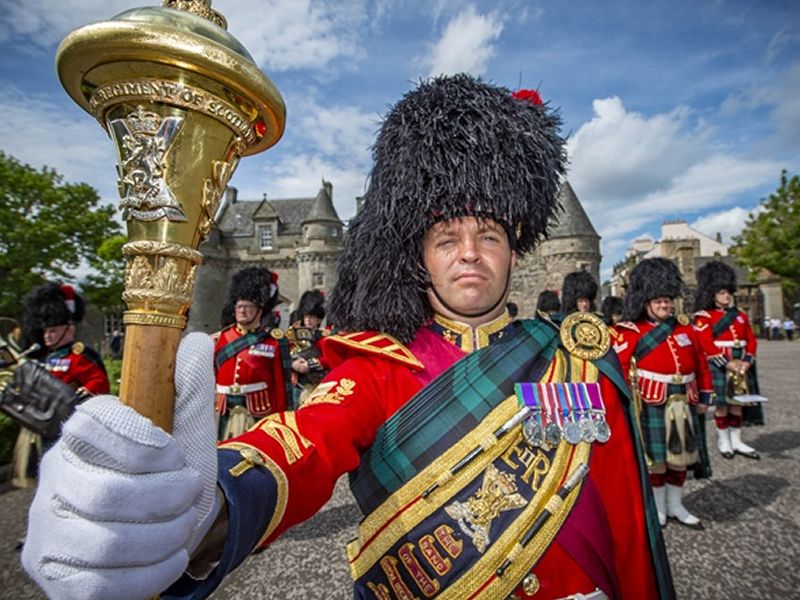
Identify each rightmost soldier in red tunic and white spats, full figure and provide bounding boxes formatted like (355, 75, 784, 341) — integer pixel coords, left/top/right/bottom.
(694, 261, 764, 459)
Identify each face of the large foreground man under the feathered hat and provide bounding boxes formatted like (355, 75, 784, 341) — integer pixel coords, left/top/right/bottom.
(422, 217, 517, 326)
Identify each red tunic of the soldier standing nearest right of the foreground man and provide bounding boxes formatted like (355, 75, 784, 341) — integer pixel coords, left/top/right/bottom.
(612, 320, 713, 404)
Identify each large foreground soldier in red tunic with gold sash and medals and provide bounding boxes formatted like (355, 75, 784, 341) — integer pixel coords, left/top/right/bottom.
(23, 75, 674, 600)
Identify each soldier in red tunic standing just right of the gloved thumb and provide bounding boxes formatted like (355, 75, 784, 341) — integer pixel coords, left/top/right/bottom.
(214, 267, 288, 440)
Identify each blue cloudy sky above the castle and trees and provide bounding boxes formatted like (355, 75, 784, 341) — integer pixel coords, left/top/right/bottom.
(0, 0, 800, 278)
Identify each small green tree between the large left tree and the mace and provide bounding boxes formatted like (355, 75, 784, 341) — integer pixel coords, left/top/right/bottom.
(81, 235, 128, 313)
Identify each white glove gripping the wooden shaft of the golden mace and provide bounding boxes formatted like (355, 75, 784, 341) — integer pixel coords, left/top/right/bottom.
(22, 333, 219, 599)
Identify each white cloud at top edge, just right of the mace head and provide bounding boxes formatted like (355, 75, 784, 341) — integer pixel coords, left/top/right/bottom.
(219, 0, 367, 72)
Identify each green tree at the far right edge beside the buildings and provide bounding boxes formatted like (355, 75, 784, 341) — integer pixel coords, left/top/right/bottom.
(731, 170, 800, 294)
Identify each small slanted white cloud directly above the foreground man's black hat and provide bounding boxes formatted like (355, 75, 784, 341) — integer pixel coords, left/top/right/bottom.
(421, 5, 504, 75)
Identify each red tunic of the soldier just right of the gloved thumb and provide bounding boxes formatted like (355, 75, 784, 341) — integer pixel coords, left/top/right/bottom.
(214, 325, 287, 417)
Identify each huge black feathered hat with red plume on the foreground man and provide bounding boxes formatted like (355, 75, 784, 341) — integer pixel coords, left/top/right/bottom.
(329, 74, 565, 343)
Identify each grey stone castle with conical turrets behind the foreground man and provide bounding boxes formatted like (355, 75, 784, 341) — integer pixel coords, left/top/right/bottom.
(189, 180, 600, 332)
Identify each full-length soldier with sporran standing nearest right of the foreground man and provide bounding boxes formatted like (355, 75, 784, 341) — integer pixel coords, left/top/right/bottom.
(614, 258, 712, 529)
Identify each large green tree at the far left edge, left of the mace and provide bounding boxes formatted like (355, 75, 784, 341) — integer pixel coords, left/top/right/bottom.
(0, 152, 120, 316)
